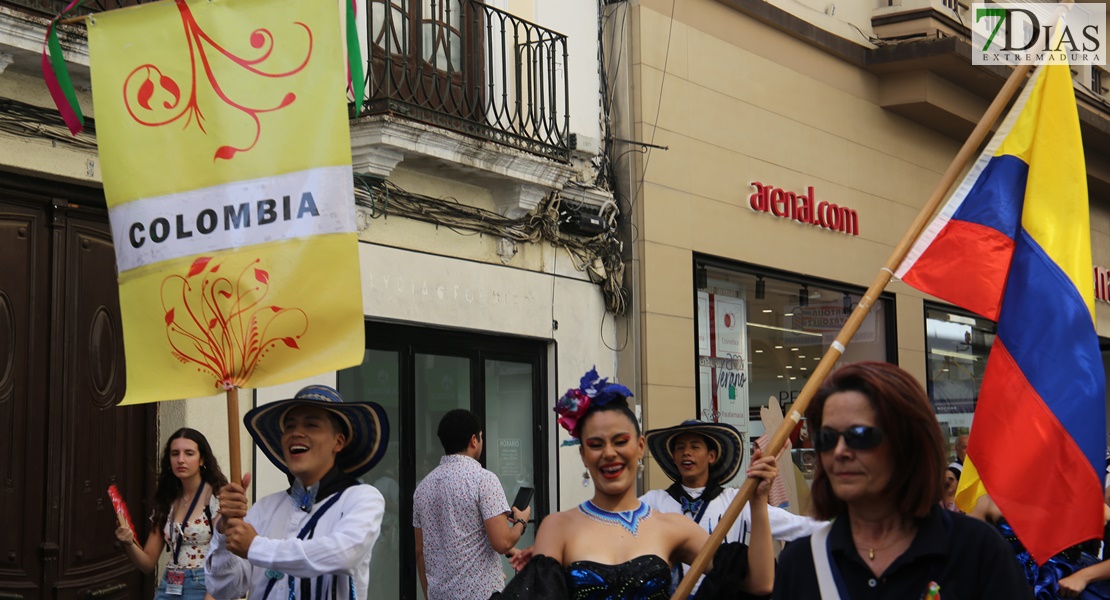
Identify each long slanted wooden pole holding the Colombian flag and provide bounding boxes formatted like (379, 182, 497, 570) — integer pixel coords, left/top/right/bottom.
(670, 64, 1031, 600)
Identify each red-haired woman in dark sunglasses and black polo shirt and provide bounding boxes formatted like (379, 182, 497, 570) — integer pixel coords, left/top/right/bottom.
(774, 363, 1032, 600)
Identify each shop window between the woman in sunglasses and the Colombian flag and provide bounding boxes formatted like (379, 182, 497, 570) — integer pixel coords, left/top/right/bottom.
(925, 305, 997, 459)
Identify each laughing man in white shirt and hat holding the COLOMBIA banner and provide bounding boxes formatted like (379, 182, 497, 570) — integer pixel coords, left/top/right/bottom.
(204, 385, 389, 600)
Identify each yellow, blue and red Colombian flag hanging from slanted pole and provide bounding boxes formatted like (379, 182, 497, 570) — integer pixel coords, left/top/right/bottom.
(897, 64, 1106, 563)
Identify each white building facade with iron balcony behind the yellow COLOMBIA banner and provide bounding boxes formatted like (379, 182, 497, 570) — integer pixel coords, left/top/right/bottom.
(0, 0, 627, 598)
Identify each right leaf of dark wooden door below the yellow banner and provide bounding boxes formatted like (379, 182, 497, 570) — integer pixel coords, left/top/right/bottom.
(47, 207, 150, 600)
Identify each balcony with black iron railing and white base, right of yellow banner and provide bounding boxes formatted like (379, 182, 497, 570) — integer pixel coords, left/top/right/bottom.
(351, 0, 574, 215)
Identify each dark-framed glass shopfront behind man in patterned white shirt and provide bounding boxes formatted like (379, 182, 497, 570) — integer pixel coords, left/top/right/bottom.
(337, 323, 551, 599)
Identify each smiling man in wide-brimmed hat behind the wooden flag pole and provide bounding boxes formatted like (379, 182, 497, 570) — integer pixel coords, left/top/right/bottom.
(640, 420, 820, 590)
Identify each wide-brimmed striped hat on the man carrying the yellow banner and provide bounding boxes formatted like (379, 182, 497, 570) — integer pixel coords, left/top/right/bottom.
(243, 385, 390, 477)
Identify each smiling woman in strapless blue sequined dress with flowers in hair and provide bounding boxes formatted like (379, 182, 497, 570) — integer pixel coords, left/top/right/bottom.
(502, 370, 778, 600)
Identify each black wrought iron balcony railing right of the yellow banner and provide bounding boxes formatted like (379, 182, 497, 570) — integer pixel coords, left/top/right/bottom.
(363, 0, 569, 161)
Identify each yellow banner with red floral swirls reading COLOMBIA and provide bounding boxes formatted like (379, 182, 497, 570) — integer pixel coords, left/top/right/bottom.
(89, 0, 363, 404)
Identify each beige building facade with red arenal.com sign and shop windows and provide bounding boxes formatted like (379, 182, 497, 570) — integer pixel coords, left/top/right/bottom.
(606, 0, 1110, 510)
